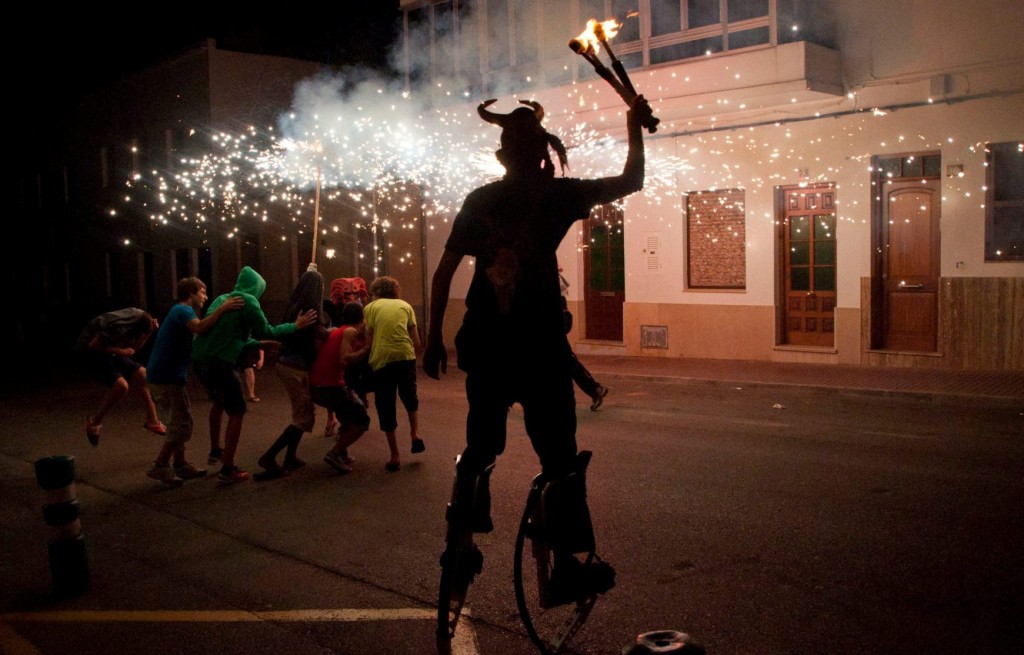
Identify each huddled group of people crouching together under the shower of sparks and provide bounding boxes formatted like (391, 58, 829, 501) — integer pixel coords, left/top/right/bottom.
(75, 264, 426, 486)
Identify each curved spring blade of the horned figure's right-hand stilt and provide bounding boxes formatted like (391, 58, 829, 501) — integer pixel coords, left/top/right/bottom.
(513, 453, 600, 655)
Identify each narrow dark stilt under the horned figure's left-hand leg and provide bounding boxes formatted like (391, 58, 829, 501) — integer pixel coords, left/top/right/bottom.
(437, 457, 494, 655)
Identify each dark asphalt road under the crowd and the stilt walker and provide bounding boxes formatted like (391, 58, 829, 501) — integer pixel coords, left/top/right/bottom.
(0, 370, 1024, 655)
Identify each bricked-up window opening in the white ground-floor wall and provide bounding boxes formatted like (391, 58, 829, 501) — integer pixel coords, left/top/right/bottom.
(686, 188, 746, 289)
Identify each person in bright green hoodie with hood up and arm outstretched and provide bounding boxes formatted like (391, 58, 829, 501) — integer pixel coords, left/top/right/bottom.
(193, 266, 316, 482)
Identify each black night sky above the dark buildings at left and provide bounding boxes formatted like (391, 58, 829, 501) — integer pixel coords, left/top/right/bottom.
(19, 0, 401, 108)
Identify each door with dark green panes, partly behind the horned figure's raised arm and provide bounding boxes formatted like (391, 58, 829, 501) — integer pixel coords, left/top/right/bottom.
(584, 205, 626, 342)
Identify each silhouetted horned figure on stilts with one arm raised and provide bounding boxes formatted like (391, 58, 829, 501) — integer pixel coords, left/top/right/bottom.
(423, 96, 650, 601)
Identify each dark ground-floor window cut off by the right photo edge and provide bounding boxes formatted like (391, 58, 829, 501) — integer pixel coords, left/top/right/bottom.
(985, 141, 1024, 262)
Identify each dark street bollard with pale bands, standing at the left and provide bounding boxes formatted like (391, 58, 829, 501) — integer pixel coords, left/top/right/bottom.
(36, 455, 89, 598)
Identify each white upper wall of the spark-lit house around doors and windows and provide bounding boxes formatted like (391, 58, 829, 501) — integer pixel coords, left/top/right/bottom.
(419, 0, 1024, 317)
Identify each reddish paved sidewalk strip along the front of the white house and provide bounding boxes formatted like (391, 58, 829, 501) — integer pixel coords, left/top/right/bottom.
(580, 355, 1024, 404)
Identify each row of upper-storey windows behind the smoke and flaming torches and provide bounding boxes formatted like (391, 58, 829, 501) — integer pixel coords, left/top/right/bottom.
(406, 0, 811, 94)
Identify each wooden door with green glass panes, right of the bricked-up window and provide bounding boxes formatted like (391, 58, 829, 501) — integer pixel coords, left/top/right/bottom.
(779, 184, 837, 347)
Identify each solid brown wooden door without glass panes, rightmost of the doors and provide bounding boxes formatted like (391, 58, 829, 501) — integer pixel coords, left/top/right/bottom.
(882, 179, 940, 352)
